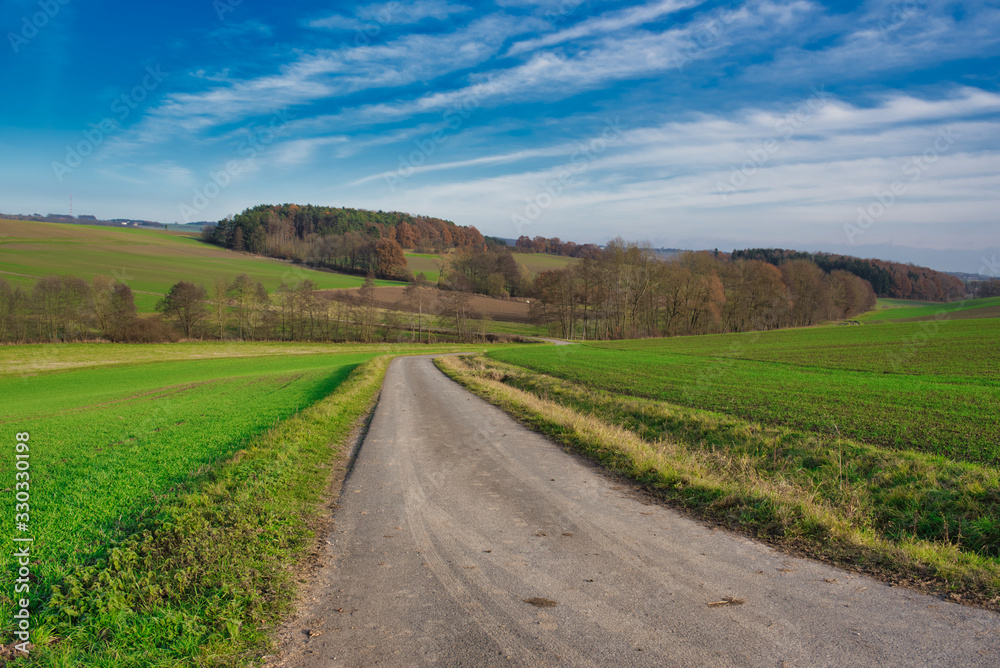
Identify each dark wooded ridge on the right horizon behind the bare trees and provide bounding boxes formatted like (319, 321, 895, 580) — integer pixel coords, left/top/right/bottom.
(732, 248, 966, 302)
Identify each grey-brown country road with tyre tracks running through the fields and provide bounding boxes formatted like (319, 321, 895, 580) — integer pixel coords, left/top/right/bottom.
(282, 358, 1000, 668)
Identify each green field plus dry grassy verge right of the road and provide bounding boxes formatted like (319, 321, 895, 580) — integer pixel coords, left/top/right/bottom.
(439, 320, 1000, 610)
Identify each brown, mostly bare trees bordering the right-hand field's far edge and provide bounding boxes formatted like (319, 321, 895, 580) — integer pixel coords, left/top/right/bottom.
(532, 238, 875, 339)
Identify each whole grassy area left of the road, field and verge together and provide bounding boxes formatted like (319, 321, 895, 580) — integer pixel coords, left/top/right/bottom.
(0, 343, 468, 667)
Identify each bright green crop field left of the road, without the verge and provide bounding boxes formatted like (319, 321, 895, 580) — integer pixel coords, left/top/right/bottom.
(0, 353, 374, 619)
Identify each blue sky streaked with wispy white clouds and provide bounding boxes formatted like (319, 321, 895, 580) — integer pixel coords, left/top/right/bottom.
(0, 0, 1000, 276)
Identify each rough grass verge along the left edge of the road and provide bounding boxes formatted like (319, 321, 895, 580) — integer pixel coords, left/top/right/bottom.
(5, 356, 391, 668)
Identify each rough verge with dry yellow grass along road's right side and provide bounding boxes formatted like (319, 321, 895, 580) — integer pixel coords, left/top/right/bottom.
(435, 356, 1000, 610)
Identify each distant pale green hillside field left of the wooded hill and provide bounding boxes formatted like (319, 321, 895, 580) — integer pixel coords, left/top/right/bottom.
(0, 220, 399, 311)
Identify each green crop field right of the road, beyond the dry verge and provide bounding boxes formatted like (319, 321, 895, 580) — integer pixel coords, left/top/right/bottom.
(491, 320, 1000, 465)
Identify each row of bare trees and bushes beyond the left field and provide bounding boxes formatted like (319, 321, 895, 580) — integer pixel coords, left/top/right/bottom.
(0, 274, 504, 343)
